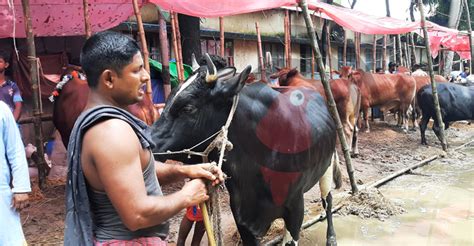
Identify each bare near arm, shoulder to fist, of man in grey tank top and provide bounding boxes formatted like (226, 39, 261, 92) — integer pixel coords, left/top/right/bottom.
(82, 119, 209, 230)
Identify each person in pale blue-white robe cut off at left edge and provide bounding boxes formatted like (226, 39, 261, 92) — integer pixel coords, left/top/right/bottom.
(0, 101, 31, 246)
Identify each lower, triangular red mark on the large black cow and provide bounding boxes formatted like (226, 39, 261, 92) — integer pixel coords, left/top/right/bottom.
(260, 166, 301, 206)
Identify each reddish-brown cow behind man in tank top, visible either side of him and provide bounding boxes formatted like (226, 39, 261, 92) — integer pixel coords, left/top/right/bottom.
(53, 67, 159, 148)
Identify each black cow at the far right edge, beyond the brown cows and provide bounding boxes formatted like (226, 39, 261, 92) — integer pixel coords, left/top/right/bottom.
(416, 83, 474, 145)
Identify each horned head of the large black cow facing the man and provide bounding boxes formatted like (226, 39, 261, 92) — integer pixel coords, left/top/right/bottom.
(152, 56, 251, 163)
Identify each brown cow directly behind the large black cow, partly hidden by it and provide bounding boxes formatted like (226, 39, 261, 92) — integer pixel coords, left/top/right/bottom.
(270, 68, 361, 156)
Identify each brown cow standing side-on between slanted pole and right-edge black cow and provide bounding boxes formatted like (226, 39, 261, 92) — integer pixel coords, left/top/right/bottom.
(339, 66, 416, 132)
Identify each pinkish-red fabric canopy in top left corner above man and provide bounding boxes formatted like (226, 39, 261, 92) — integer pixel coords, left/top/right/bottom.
(0, 0, 142, 38)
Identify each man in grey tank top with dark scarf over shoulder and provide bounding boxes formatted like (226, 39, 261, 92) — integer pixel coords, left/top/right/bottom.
(64, 32, 223, 245)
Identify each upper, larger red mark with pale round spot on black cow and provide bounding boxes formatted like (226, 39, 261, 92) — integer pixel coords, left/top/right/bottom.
(256, 89, 312, 154)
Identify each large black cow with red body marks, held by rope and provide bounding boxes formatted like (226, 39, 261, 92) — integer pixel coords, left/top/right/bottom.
(152, 58, 341, 245)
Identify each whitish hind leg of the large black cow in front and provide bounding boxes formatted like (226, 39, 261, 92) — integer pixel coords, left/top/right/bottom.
(319, 155, 337, 245)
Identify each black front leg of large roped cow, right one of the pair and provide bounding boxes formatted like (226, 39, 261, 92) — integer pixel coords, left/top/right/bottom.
(282, 196, 304, 245)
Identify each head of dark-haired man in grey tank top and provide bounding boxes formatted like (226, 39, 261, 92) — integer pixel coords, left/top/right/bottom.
(81, 31, 150, 106)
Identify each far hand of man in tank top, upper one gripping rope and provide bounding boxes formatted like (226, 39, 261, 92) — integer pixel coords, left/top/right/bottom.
(183, 163, 224, 186)
